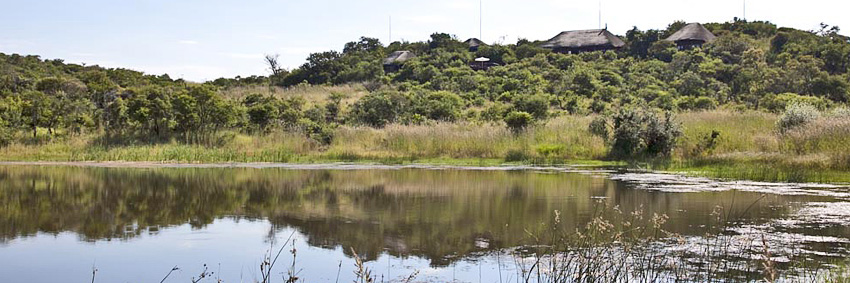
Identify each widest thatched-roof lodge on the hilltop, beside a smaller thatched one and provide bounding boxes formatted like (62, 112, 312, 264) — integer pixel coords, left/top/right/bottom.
(540, 29, 626, 54)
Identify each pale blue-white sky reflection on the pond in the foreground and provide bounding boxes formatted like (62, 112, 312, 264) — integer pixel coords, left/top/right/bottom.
(0, 218, 516, 282)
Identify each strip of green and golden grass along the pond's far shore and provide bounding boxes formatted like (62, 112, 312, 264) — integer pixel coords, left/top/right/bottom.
(0, 110, 850, 182)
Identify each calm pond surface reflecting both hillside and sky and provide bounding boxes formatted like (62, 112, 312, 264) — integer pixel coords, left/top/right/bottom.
(0, 165, 850, 282)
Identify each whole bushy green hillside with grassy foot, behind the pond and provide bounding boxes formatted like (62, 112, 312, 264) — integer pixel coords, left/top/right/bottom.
(0, 20, 850, 180)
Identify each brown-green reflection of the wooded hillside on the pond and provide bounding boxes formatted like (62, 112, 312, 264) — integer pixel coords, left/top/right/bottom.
(0, 167, 832, 265)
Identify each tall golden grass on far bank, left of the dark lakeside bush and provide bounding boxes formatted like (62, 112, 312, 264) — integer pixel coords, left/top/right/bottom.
(327, 116, 606, 162)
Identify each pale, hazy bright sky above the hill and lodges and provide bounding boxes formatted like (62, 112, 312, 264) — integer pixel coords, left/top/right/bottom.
(0, 0, 850, 82)
